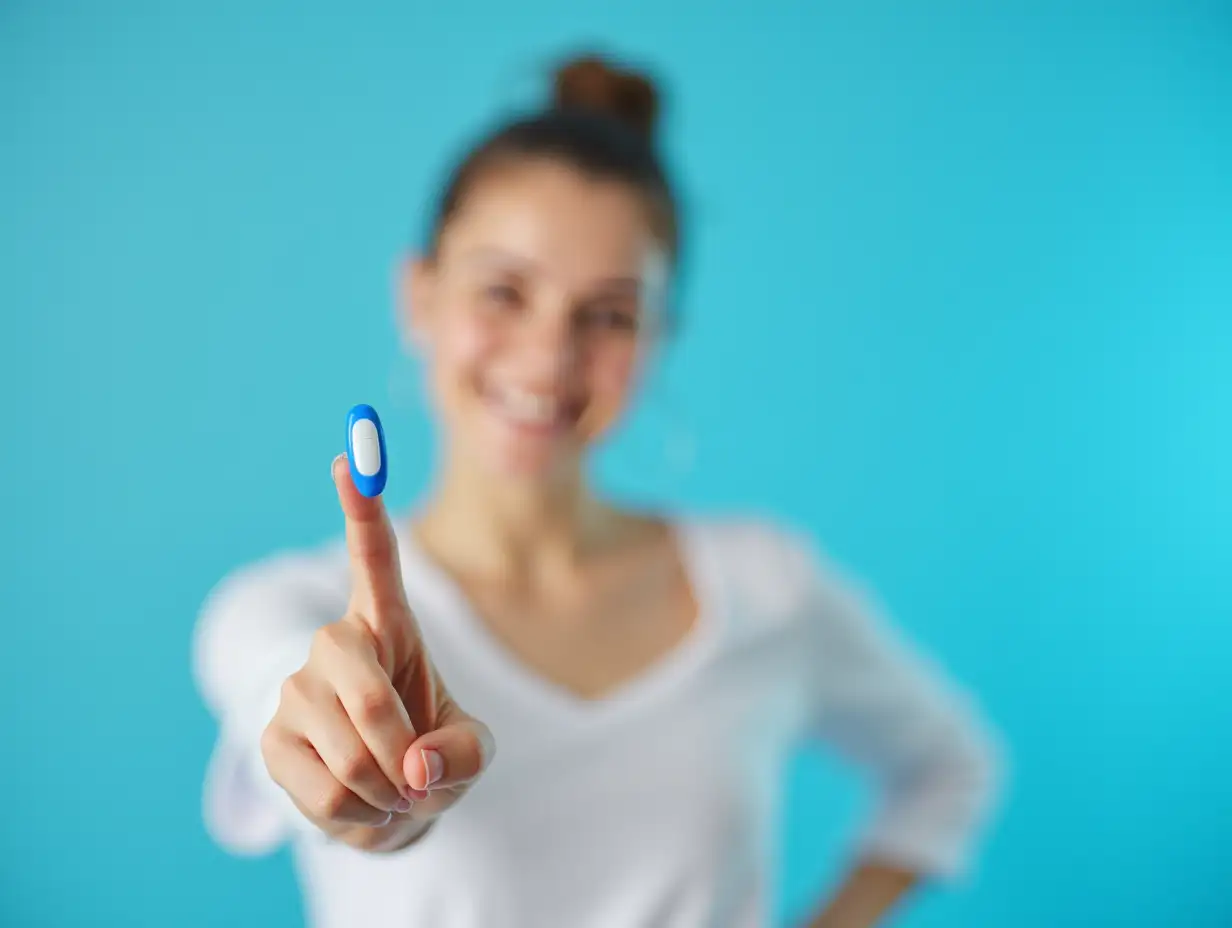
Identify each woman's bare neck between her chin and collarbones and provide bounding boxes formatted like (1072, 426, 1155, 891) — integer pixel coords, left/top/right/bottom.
(415, 438, 618, 578)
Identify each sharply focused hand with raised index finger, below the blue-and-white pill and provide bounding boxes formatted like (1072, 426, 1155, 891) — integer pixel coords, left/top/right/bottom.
(261, 455, 494, 850)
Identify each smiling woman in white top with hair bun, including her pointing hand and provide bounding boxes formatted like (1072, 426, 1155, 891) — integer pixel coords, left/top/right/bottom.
(196, 52, 993, 928)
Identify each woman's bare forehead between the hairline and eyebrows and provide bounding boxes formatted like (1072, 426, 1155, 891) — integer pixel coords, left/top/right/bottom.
(440, 160, 664, 286)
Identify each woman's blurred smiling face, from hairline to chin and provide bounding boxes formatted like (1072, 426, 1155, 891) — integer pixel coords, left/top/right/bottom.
(404, 160, 668, 481)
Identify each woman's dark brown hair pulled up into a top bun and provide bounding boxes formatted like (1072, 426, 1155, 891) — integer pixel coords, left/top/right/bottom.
(428, 54, 680, 277)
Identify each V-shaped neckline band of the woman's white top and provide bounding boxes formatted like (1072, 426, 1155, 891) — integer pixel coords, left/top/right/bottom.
(394, 518, 724, 722)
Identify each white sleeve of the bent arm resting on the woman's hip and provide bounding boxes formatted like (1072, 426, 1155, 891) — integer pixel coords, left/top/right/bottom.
(788, 527, 1005, 881)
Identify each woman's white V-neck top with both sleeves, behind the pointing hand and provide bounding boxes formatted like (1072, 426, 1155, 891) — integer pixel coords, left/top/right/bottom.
(195, 519, 1000, 928)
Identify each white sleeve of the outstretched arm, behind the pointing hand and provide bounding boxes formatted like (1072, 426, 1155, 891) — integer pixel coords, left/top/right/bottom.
(192, 555, 345, 854)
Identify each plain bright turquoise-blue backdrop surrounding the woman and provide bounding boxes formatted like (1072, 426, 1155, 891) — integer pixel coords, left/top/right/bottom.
(0, 0, 1232, 928)
